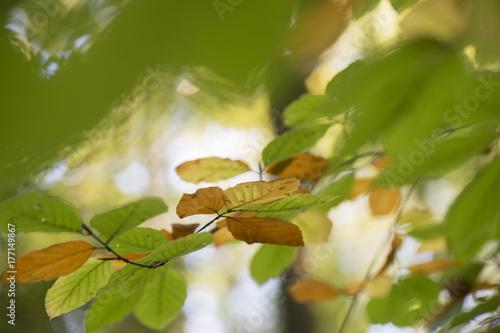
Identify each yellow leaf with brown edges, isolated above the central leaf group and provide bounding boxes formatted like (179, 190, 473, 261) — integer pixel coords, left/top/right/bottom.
(175, 157, 252, 184)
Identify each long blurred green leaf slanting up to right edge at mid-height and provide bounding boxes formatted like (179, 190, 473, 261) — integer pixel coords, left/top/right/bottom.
(380, 121, 498, 185)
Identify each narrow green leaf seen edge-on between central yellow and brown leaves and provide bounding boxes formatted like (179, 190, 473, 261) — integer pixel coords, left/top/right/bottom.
(235, 193, 336, 212)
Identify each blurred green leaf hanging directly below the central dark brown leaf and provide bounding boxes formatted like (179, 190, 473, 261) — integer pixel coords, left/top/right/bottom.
(250, 244, 297, 284)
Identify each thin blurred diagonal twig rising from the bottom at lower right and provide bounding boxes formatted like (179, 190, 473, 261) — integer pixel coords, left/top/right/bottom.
(339, 180, 418, 333)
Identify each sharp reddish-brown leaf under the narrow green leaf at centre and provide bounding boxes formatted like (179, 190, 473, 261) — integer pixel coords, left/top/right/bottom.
(227, 216, 304, 246)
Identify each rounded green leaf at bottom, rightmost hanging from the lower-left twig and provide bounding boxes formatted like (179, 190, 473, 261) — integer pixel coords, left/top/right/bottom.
(134, 269, 187, 329)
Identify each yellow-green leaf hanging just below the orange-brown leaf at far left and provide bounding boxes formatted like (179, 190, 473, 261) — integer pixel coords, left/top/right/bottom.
(45, 259, 113, 318)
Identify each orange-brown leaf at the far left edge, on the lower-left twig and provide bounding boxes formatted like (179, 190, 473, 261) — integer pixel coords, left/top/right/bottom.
(0, 240, 95, 282)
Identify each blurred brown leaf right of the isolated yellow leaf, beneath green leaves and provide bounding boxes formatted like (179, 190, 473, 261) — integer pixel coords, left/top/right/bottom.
(266, 153, 328, 181)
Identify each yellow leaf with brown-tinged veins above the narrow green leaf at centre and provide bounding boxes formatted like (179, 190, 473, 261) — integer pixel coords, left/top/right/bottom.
(222, 178, 300, 209)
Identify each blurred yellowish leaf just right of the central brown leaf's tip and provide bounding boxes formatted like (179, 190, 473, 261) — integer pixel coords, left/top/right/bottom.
(292, 210, 332, 244)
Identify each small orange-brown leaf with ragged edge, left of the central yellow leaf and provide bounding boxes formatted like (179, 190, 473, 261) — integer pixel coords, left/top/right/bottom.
(177, 186, 224, 218)
